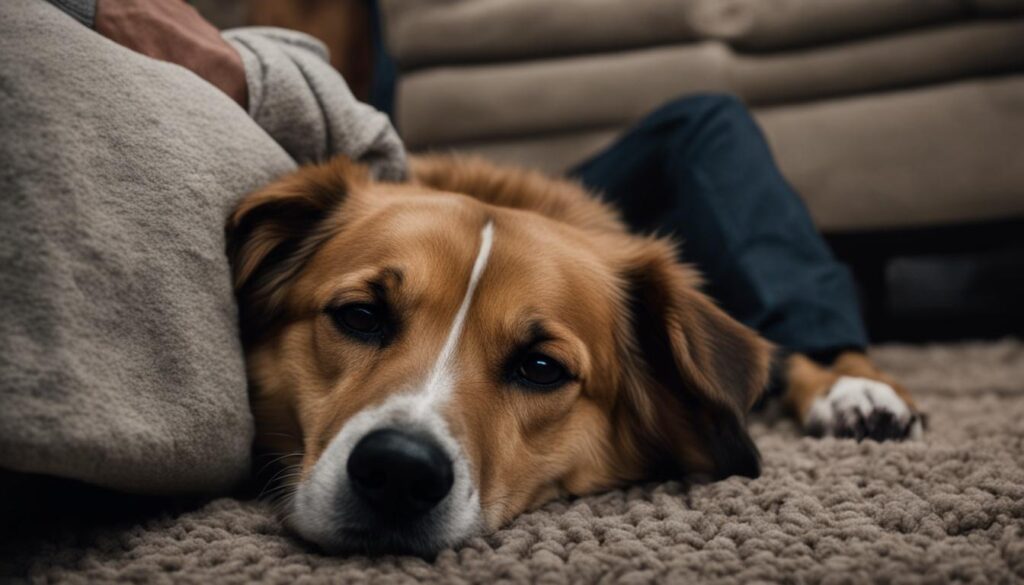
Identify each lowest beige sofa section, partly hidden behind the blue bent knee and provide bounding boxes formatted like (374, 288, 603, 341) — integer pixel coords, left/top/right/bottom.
(448, 76, 1024, 233)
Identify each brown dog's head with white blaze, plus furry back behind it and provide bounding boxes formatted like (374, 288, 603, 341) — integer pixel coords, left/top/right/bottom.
(228, 153, 769, 554)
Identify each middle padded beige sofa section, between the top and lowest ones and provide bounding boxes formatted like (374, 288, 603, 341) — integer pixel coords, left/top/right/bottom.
(396, 18, 1024, 148)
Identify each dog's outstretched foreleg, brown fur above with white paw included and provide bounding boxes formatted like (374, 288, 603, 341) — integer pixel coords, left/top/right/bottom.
(783, 351, 923, 441)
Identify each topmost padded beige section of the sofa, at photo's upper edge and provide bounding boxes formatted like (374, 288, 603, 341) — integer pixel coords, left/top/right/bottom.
(381, 0, 1024, 69)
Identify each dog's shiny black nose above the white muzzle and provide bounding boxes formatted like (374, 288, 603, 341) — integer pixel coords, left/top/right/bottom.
(348, 428, 455, 519)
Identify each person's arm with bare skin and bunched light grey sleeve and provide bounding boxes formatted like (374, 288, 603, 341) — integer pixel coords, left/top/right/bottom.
(50, 0, 407, 180)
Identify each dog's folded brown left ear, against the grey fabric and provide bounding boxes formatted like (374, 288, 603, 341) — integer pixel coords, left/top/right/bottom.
(226, 157, 370, 341)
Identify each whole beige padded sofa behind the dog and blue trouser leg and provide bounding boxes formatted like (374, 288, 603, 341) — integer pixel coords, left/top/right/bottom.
(380, 0, 1024, 234)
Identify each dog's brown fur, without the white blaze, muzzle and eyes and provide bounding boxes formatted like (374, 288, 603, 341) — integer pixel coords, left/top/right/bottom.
(228, 157, 913, 528)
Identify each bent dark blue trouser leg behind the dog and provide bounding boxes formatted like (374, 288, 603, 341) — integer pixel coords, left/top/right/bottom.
(571, 95, 867, 354)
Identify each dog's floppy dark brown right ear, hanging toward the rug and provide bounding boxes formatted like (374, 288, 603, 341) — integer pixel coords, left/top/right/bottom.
(610, 239, 771, 478)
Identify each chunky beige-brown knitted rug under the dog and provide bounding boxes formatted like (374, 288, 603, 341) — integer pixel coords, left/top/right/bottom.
(3, 340, 1024, 584)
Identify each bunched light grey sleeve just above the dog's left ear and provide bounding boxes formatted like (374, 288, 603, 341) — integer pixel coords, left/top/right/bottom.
(223, 27, 407, 180)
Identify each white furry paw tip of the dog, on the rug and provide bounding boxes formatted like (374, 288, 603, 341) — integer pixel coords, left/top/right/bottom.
(805, 376, 924, 441)
